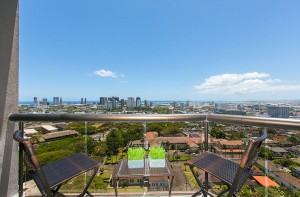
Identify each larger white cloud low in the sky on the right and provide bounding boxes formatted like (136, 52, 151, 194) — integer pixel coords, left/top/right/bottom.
(194, 72, 300, 95)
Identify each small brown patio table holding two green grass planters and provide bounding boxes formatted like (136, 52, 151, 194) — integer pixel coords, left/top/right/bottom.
(112, 158, 174, 197)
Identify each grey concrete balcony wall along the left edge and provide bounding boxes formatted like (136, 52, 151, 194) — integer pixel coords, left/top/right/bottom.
(0, 0, 19, 197)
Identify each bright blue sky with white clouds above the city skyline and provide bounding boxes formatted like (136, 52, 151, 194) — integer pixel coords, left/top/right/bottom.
(20, 0, 300, 101)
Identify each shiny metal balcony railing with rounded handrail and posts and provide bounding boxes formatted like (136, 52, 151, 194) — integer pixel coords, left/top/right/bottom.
(9, 113, 300, 196)
